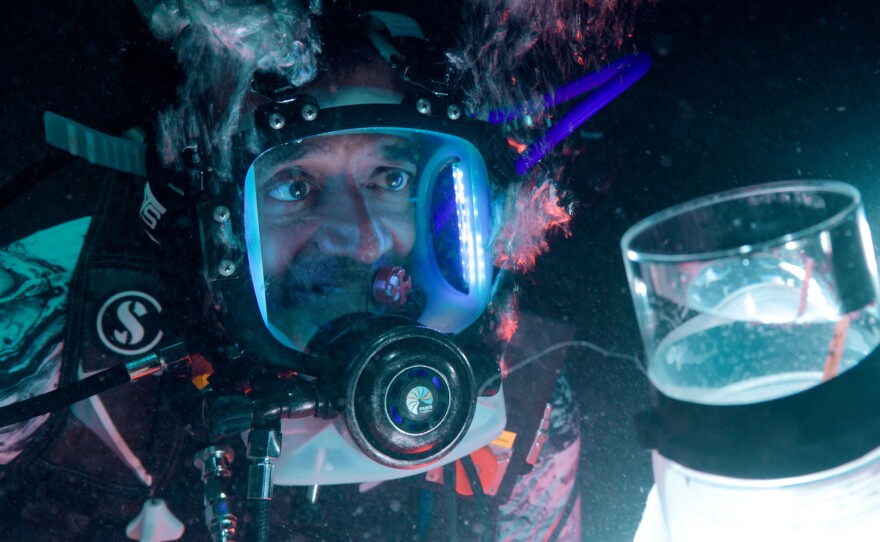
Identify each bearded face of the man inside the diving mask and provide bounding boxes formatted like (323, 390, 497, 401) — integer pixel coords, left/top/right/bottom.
(255, 134, 419, 348)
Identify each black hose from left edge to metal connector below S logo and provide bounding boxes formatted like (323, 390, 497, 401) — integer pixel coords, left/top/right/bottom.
(0, 364, 131, 427)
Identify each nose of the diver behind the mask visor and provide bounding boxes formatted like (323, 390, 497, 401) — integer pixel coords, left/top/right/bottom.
(315, 185, 394, 263)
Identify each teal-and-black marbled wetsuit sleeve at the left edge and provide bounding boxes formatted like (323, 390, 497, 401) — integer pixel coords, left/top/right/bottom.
(0, 218, 90, 466)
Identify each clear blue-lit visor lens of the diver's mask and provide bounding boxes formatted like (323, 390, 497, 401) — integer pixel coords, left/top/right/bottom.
(245, 129, 491, 350)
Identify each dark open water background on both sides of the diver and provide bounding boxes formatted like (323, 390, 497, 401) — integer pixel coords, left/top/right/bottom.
(0, 0, 880, 542)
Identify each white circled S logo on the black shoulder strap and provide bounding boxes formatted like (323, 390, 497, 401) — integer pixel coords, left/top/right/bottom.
(97, 290, 163, 356)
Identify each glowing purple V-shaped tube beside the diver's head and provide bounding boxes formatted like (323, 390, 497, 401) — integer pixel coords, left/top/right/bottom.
(488, 53, 651, 175)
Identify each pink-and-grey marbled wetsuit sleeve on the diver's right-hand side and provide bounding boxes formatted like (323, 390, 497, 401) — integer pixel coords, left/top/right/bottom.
(496, 373, 581, 542)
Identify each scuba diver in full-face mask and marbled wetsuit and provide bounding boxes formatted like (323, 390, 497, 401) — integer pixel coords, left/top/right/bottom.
(0, 0, 647, 541)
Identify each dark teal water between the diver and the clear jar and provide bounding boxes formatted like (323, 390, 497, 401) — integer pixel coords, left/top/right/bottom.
(532, 1, 880, 542)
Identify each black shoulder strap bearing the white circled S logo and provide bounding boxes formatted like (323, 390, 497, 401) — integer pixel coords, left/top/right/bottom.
(45, 169, 200, 485)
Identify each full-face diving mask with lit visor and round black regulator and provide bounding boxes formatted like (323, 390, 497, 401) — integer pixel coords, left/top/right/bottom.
(220, 91, 506, 485)
